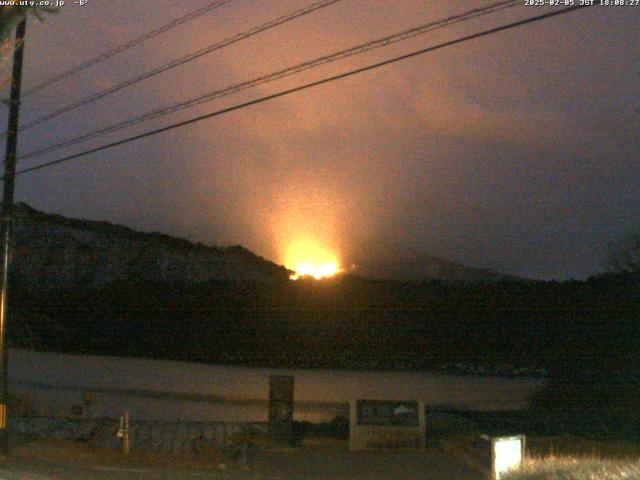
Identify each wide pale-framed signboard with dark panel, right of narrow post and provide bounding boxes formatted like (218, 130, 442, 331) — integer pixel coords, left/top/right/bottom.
(349, 400, 425, 450)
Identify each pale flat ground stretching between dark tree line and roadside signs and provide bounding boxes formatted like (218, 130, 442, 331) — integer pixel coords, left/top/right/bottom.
(9, 349, 544, 422)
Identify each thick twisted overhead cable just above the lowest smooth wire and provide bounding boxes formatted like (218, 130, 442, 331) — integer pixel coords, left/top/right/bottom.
(18, 0, 519, 159)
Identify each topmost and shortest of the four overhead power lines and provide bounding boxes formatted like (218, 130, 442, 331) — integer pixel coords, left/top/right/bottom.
(23, 0, 238, 97)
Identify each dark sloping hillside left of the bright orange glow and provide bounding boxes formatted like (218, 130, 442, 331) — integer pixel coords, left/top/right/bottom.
(12, 203, 289, 289)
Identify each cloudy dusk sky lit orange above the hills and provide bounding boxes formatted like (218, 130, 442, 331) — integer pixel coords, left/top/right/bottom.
(0, 0, 640, 279)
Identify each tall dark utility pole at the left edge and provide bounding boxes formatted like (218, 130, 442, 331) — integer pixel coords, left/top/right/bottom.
(0, 15, 27, 453)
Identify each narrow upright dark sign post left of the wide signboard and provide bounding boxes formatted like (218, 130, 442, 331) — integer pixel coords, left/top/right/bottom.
(269, 375, 293, 445)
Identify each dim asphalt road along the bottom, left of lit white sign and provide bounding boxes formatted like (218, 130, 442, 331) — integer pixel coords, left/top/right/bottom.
(0, 449, 480, 480)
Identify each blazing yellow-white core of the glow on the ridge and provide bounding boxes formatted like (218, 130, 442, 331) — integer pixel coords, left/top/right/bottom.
(284, 240, 342, 280)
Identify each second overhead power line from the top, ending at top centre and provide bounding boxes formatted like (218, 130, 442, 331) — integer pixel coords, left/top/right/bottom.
(13, 0, 341, 131)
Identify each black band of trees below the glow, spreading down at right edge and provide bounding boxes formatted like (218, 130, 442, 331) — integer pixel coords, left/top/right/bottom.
(10, 272, 640, 434)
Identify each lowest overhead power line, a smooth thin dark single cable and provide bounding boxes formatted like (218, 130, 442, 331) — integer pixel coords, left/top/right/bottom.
(15, 5, 588, 180)
